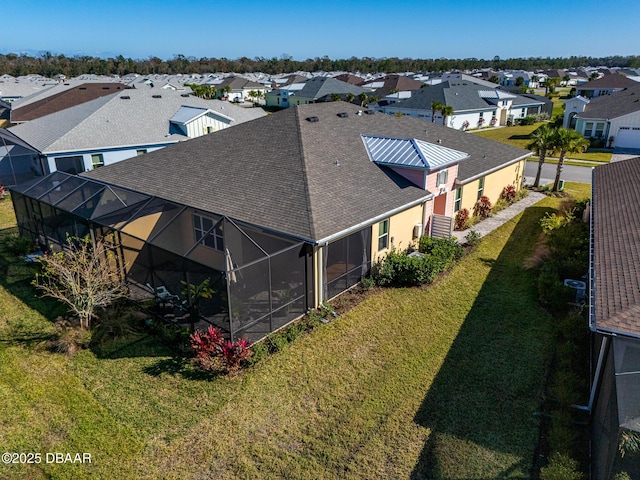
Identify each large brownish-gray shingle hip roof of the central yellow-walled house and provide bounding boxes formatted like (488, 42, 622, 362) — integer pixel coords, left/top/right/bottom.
(85, 102, 531, 241)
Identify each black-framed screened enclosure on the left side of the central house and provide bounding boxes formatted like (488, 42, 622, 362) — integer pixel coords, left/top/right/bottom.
(11, 172, 314, 341)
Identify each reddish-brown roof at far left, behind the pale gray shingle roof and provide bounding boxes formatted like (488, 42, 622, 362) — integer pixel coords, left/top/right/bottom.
(10, 82, 128, 123)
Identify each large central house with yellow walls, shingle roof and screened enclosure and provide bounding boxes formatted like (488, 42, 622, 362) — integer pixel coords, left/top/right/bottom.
(11, 102, 531, 340)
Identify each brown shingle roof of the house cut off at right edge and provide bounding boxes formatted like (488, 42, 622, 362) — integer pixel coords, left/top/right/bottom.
(592, 158, 640, 336)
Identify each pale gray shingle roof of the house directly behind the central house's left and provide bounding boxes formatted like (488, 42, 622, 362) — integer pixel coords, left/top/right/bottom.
(10, 89, 266, 153)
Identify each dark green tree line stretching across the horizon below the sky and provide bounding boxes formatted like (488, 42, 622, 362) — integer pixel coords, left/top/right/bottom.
(0, 52, 640, 77)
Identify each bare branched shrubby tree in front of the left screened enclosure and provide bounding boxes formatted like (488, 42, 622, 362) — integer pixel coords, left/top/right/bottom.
(33, 236, 127, 328)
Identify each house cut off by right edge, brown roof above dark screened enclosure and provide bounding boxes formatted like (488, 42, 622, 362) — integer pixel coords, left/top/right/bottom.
(588, 158, 640, 479)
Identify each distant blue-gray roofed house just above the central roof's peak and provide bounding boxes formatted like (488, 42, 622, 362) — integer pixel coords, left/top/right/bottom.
(265, 77, 368, 108)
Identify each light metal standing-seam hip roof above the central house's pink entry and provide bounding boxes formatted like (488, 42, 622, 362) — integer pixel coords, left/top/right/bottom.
(362, 135, 469, 171)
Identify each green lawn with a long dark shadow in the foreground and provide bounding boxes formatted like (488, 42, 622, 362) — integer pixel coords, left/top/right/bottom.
(0, 192, 583, 480)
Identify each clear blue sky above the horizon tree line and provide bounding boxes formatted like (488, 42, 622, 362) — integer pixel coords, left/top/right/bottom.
(0, 0, 640, 60)
